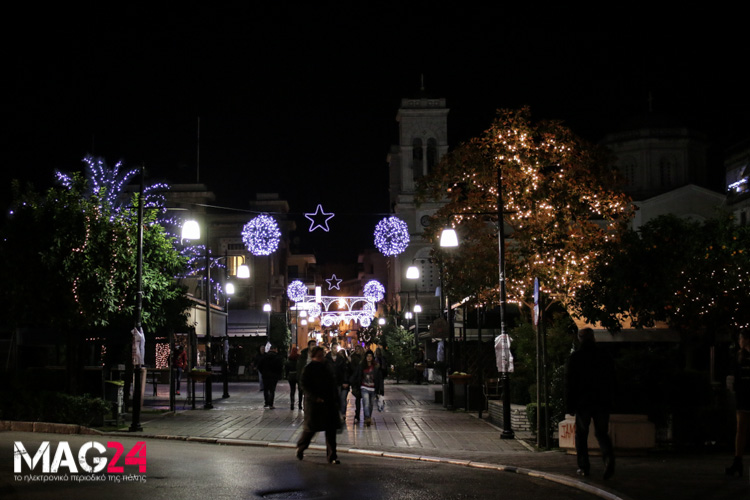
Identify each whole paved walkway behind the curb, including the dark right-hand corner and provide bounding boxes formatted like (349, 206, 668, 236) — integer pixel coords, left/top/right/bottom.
(10, 381, 750, 500)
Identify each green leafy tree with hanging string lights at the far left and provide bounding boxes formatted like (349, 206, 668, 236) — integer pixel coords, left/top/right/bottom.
(0, 166, 187, 388)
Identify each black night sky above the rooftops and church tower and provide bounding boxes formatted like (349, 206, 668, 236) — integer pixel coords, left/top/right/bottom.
(3, 4, 750, 262)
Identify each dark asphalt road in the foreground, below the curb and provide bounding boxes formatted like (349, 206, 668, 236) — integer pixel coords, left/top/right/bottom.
(0, 432, 596, 500)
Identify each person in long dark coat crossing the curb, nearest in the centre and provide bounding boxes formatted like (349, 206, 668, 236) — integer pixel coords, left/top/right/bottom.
(297, 346, 341, 464)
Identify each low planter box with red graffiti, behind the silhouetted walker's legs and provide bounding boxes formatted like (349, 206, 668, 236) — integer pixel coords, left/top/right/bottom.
(558, 414, 656, 453)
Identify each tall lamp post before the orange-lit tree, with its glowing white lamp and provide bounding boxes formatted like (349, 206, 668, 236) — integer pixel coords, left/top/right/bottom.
(440, 165, 514, 439)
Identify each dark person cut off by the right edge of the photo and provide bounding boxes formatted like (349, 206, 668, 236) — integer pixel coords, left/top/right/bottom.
(726, 329, 750, 477)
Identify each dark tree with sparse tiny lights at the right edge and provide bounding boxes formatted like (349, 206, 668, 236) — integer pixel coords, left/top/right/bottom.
(575, 216, 750, 332)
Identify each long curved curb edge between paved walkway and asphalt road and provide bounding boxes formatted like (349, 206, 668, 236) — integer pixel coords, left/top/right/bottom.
(0, 420, 630, 500)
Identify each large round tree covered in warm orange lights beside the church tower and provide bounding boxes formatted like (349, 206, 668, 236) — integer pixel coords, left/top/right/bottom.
(418, 108, 632, 310)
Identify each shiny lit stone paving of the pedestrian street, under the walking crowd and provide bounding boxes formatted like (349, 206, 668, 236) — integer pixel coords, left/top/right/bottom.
(141, 381, 529, 455)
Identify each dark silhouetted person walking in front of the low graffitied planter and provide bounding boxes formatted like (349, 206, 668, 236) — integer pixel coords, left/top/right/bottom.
(565, 328, 615, 479)
